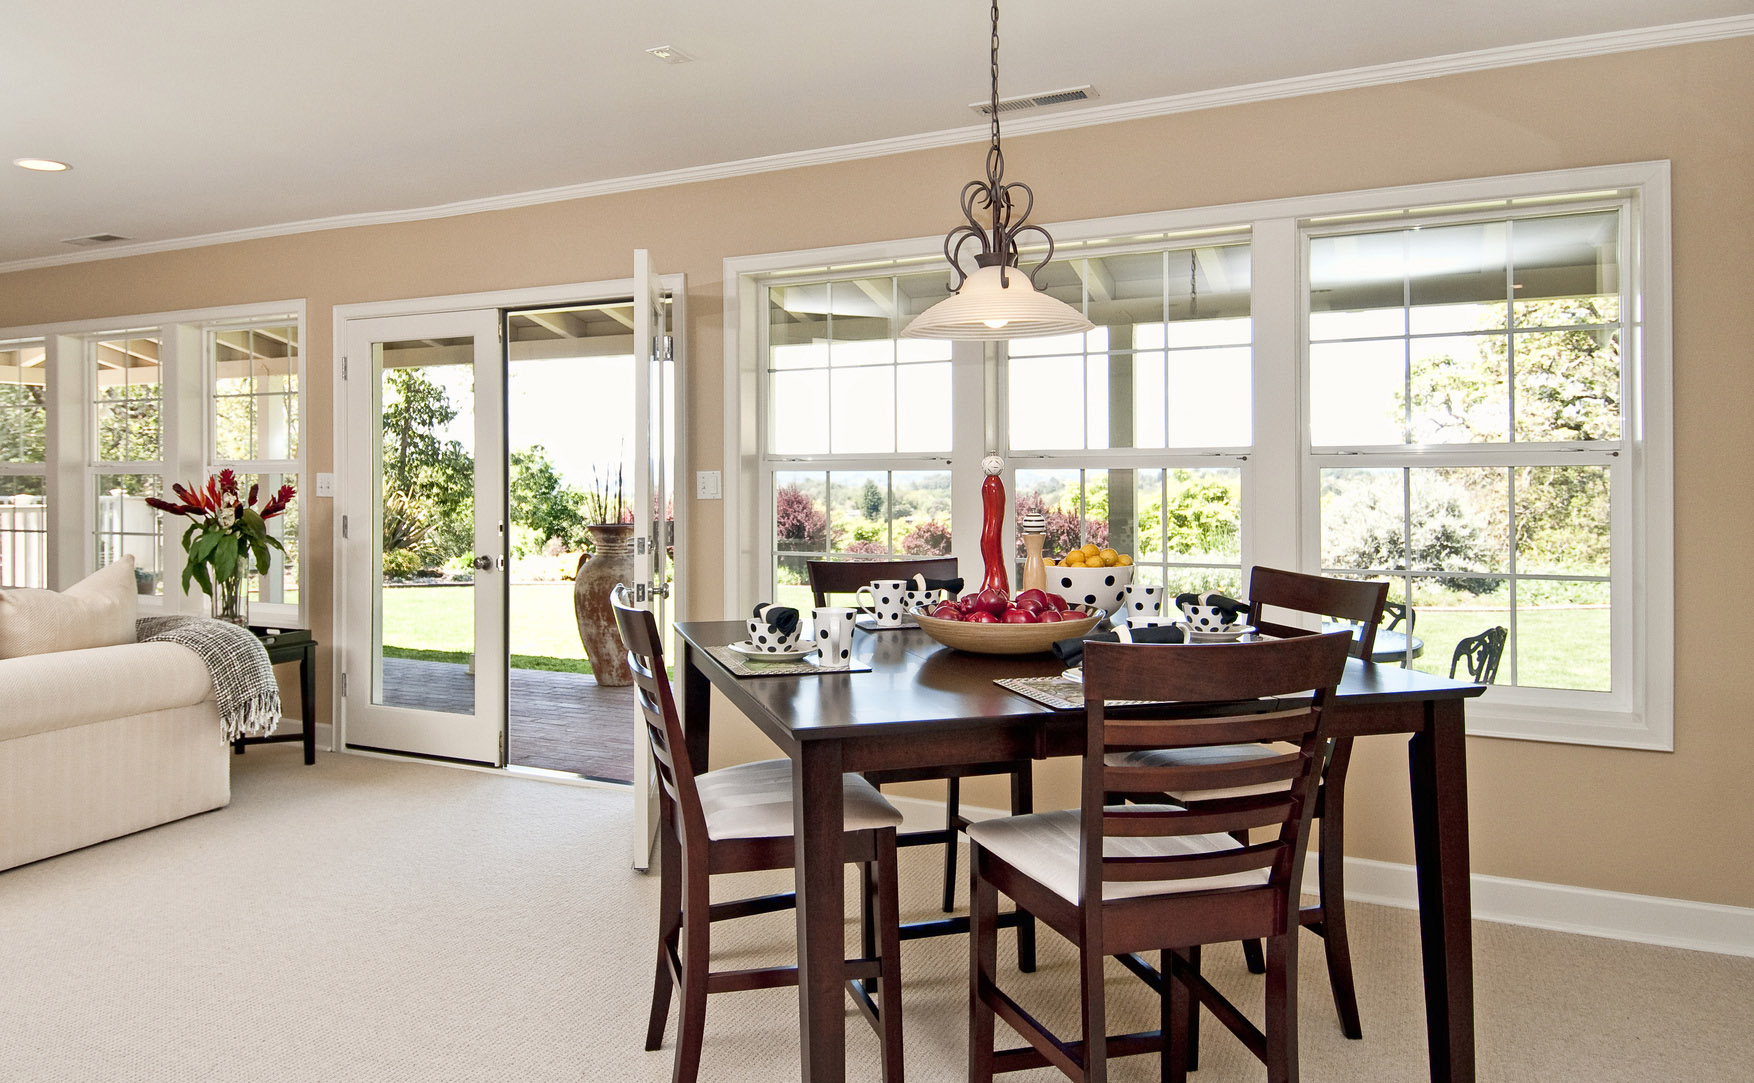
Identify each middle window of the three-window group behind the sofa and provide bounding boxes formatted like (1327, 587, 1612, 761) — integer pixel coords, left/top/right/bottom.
(86, 328, 165, 595)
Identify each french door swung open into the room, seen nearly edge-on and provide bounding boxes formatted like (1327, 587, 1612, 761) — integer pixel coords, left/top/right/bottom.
(633, 249, 675, 869)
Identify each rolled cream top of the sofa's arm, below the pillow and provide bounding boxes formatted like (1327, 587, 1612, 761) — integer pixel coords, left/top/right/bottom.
(0, 642, 219, 741)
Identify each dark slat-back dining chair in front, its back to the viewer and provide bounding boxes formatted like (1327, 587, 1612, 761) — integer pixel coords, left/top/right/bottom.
(968, 632, 1351, 1083)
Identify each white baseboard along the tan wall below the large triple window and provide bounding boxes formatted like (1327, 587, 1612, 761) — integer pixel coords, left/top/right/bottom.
(886, 795, 1754, 957)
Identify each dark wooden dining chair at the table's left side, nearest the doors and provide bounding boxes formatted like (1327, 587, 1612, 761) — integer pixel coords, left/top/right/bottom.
(612, 586, 902, 1083)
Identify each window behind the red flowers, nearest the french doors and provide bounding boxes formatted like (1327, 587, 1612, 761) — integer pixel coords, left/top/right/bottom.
(203, 321, 303, 613)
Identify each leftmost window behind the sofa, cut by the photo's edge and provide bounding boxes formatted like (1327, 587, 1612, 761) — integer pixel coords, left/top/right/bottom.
(0, 339, 49, 586)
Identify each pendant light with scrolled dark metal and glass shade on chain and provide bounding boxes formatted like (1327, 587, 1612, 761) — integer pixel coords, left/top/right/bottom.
(902, 0, 1094, 341)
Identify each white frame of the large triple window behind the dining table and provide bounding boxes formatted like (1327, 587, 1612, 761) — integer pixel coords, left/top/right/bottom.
(723, 161, 1675, 751)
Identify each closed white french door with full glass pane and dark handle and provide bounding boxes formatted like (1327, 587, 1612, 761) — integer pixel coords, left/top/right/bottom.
(337, 309, 507, 767)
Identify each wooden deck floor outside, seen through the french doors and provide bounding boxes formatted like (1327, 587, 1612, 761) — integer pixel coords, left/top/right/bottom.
(384, 658, 633, 783)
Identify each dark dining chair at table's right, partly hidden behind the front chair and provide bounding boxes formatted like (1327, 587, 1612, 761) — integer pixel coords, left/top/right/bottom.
(1126, 565, 1389, 1037)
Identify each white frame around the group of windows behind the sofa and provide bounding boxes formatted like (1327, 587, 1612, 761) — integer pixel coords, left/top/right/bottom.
(0, 298, 309, 628)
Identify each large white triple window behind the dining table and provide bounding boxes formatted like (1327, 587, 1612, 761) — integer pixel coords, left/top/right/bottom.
(740, 161, 1673, 749)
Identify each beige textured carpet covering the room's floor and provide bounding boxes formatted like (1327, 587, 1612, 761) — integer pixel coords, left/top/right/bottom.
(0, 744, 1754, 1083)
